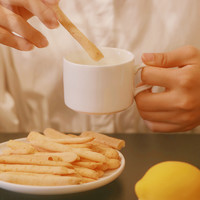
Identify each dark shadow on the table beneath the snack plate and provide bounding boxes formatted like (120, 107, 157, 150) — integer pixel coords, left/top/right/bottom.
(0, 179, 123, 200)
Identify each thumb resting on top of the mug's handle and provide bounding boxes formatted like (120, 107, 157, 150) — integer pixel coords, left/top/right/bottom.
(142, 46, 200, 67)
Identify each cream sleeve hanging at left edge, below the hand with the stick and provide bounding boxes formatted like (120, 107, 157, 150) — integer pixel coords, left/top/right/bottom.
(0, 45, 28, 132)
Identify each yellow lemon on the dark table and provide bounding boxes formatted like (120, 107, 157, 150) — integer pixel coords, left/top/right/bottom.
(135, 161, 200, 200)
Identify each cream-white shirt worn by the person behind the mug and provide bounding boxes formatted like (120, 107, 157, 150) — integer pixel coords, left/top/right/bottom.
(0, 0, 200, 133)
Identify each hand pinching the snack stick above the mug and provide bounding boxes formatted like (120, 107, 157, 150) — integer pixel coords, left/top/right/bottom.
(0, 0, 58, 51)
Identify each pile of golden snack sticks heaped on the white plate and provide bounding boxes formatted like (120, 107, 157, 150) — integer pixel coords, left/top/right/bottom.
(0, 128, 125, 186)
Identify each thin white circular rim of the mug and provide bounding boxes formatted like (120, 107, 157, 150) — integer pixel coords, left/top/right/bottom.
(63, 47, 135, 68)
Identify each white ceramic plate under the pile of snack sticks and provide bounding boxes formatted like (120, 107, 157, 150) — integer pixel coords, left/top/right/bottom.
(0, 138, 125, 195)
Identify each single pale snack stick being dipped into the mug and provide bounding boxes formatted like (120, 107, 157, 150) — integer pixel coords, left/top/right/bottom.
(53, 6, 104, 61)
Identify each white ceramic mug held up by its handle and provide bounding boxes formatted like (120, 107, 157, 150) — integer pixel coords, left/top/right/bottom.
(63, 47, 151, 114)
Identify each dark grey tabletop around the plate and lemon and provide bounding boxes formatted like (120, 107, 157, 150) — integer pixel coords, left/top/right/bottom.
(0, 133, 200, 200)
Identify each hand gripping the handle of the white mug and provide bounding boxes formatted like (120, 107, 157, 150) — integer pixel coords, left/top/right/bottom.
(136, 46, 200, 132)
